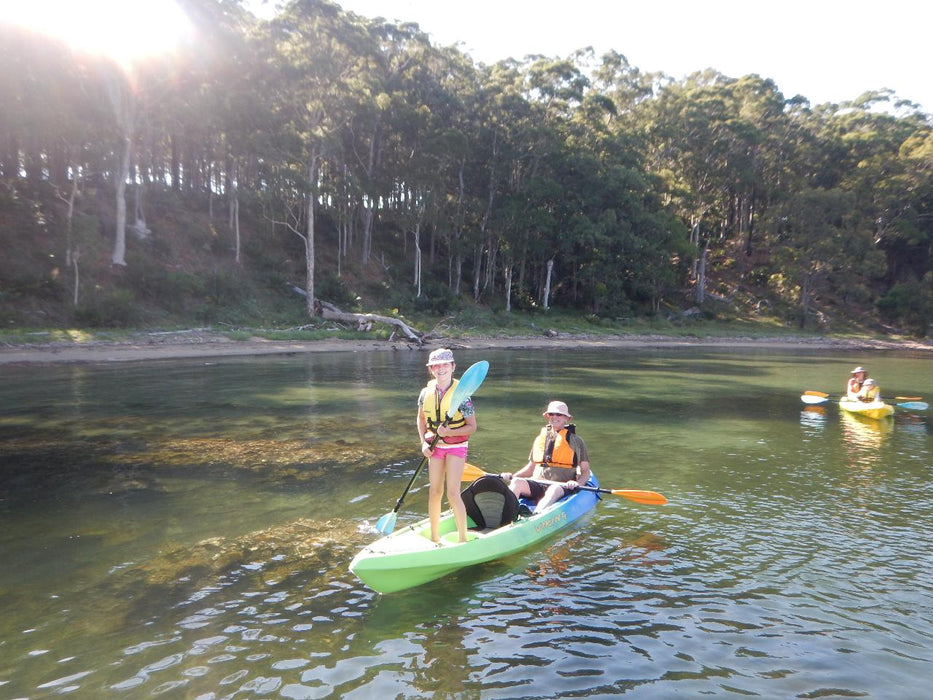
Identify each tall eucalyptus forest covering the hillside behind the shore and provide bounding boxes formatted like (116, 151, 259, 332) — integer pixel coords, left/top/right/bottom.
(0, 0, 933, 335)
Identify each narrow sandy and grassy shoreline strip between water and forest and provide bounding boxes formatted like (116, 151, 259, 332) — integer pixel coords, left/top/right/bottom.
(0, 333, 933, 365)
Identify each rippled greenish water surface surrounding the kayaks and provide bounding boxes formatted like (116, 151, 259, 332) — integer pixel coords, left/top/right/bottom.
(0, 350, 933, 698)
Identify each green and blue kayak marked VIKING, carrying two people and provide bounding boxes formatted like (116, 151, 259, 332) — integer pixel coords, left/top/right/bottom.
(350, 476, 599, 593)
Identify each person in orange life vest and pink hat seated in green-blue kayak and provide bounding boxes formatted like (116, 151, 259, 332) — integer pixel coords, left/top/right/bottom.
(502, 401, 590, 512)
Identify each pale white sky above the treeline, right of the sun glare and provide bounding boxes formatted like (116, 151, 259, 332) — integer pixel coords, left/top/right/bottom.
(324, 0, 933, 113)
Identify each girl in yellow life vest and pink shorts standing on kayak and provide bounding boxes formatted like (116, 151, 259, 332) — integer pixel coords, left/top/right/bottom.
(417, 348, 476, 542)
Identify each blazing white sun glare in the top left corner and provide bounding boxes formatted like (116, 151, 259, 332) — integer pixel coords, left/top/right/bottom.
(4, 0, 192, 65)
